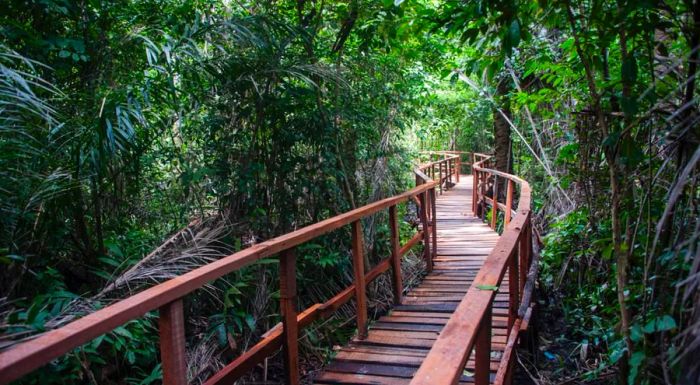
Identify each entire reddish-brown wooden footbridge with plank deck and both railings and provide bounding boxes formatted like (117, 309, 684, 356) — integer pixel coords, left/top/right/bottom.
(0, 152, 537, 385)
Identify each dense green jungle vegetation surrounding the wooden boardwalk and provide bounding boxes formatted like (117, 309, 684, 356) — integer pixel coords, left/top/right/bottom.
(0, 0, 700, 385)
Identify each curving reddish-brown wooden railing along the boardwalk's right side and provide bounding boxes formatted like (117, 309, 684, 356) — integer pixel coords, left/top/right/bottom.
(410, 153, 532, 385)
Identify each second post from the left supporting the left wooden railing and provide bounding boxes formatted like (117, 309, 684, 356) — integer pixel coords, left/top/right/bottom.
(280, 249, 299, 385)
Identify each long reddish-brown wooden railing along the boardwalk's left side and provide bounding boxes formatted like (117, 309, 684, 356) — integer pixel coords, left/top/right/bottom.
(0, 155, 459, 385)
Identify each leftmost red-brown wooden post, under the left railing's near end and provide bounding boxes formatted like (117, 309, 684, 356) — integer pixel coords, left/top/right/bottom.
(158, 299, 188, 385)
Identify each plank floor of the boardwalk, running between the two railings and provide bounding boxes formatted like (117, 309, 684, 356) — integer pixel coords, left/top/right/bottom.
(315, 175, 508, 385)
